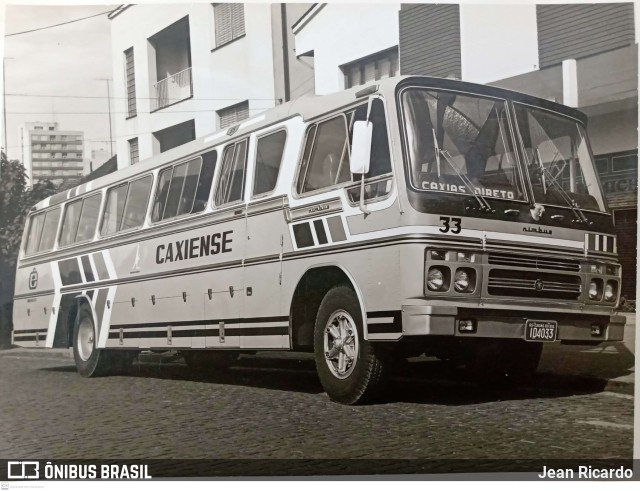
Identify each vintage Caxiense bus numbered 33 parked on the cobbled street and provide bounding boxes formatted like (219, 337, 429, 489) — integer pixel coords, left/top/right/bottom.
(13, 77, 625, 404)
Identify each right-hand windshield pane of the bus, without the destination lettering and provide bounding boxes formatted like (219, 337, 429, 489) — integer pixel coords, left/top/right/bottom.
(515, 104, 605, 211)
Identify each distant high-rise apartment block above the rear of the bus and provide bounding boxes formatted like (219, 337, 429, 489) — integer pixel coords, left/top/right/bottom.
(20, 122, 84, 186)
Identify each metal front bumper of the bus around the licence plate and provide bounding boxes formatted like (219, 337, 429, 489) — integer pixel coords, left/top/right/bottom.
(402, 305, 626, 343)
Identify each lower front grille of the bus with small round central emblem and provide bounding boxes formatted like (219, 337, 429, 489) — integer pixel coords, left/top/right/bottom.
(487, 269, 582, 300)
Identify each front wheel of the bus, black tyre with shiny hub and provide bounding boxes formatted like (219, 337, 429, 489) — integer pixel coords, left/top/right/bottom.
(313, 286, 385, 404)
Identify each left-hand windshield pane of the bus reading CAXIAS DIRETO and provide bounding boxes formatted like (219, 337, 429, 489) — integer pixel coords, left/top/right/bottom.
(402, 89, 523, 200)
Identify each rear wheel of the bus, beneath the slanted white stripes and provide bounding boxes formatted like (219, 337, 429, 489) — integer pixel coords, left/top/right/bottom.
(73, 304, 112, 377)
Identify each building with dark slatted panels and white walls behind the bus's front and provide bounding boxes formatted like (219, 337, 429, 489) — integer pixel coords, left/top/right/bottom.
(293, 3, 638, 299)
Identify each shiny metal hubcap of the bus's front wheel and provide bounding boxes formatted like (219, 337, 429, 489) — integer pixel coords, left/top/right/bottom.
(324, 310, 359, 379)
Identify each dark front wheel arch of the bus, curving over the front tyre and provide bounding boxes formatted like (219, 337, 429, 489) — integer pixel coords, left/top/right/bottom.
(289, 264, 366, 351)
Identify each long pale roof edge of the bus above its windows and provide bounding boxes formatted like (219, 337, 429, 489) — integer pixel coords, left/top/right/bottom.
(32, 76, 587, 211)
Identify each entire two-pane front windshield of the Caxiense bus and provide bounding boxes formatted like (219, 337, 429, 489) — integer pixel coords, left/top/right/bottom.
(402, 88, 606, 211)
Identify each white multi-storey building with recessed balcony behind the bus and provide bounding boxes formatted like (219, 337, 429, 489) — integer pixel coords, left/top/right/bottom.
(109, 3, 313, 167)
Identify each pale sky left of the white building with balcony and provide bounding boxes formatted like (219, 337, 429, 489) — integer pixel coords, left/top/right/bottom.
(0, 0, 117, 160)
